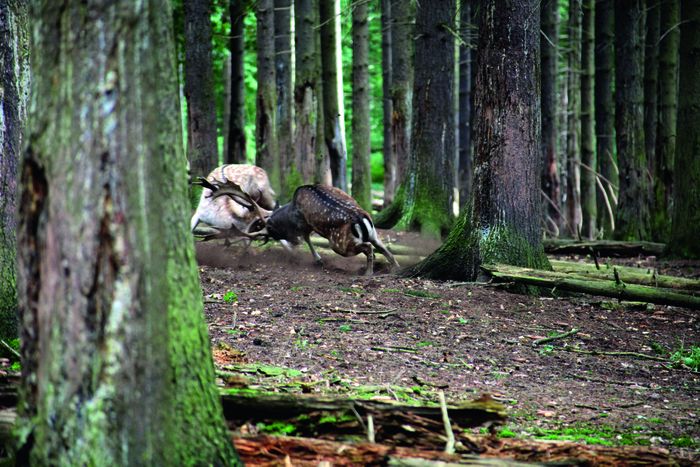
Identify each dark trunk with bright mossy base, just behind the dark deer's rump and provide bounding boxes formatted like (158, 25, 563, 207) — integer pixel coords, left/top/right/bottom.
(377, 0, 455, 237)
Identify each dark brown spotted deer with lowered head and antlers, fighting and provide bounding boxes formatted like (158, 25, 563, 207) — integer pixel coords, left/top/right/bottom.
(202, 182, 399, 275)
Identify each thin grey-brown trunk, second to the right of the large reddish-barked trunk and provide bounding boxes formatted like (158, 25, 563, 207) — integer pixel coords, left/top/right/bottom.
(565, 0, 582, 238)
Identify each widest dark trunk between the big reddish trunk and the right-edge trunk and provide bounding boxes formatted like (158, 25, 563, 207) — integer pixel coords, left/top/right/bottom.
(615, 0, 651, 240)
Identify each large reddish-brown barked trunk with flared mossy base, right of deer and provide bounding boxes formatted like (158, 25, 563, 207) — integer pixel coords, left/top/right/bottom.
(408, 0, 550, 280)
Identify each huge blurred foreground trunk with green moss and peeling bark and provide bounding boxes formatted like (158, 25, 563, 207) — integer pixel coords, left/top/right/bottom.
(17, 0, 238, 465)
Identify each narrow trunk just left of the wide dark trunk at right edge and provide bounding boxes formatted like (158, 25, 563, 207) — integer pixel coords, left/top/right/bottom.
(651, 0, 681, 241)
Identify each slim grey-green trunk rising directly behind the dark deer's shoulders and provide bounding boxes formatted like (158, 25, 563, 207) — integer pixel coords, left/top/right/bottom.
(296, 0, 322, 187)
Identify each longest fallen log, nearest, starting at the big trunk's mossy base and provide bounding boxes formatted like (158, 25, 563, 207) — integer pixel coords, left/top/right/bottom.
(481, 264, 700, 310)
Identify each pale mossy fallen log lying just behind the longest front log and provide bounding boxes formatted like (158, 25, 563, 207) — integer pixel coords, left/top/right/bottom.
(549, 259, 700, 293)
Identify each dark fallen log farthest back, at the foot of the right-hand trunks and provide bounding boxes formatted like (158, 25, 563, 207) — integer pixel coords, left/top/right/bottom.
(542, 238, 666, 257)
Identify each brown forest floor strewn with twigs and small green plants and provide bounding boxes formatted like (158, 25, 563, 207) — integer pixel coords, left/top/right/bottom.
(197, 232, 700, 462)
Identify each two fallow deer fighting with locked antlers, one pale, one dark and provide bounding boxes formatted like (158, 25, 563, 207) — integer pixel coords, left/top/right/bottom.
(191, 165, 399, 275)
